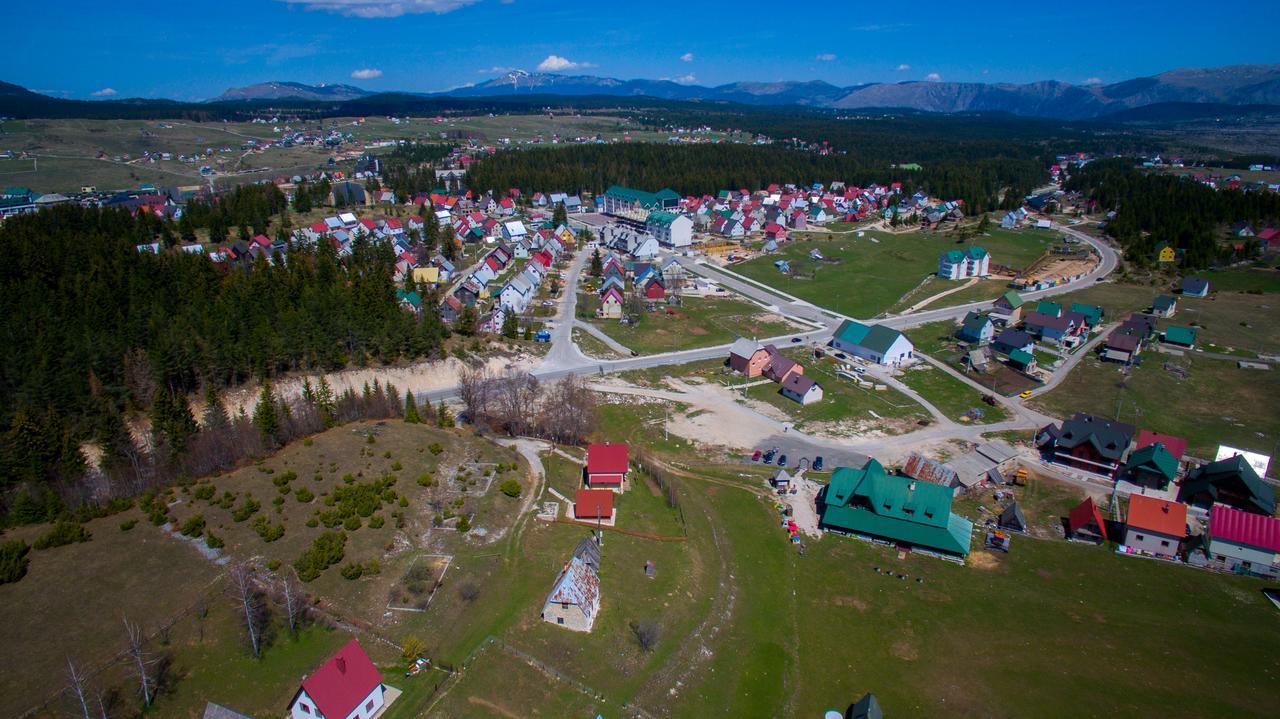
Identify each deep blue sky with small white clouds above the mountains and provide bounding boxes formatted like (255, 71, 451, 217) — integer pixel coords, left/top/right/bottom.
(10, 0, 1280, 100)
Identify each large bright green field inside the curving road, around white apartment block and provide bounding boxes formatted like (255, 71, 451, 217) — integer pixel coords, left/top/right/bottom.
(733, 230, 1056, 317)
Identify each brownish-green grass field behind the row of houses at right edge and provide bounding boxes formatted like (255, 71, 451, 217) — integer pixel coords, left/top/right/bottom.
(1033, 349, 1280, 459)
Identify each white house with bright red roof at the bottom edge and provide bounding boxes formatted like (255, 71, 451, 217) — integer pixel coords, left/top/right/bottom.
(289, 640, 385, 719)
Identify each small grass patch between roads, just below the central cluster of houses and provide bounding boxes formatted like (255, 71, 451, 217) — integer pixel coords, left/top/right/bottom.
(580, 297, 799, 354)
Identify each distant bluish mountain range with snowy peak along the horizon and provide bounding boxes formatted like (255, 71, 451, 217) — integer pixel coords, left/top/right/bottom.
(207, 65, 1280, 120)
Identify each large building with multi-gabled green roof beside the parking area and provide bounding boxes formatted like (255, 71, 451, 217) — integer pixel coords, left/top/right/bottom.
(818, 459, 973, 559)
